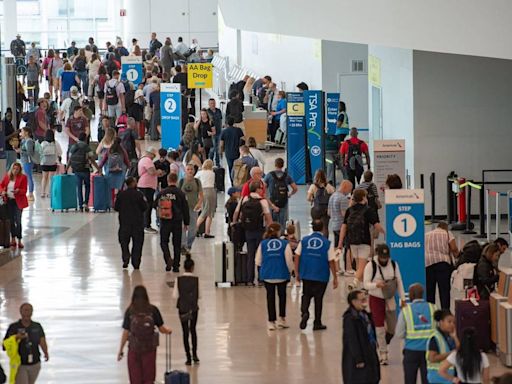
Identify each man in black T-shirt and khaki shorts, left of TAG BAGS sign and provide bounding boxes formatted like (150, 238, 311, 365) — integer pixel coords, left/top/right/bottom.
(338, 189, 384, 290)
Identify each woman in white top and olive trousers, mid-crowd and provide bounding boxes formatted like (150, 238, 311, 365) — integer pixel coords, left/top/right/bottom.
(196, 159, 217, 239)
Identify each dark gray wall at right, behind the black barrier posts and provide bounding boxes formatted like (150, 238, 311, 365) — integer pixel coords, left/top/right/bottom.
(413, 51, 512, 214)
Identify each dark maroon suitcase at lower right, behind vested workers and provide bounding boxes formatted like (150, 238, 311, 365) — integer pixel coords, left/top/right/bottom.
(455, 300, 491, 352)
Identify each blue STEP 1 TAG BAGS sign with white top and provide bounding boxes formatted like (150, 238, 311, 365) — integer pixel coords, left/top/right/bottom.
(385, 189, 426, 291)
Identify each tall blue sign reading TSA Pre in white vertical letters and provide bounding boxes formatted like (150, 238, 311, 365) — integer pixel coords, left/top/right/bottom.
(304, 91, 325, 175)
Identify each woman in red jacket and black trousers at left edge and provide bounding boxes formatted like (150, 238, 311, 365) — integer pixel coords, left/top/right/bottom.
(0, 163, 28, 249)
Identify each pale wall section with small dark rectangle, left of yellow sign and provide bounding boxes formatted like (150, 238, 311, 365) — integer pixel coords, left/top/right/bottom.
(322, 40, 369, 128)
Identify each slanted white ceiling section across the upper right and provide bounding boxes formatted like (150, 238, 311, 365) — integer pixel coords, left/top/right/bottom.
(219, 0, 512, 59)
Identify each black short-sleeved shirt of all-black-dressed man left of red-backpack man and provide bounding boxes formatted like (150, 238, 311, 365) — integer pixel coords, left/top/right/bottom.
(114, 188, 148, 228)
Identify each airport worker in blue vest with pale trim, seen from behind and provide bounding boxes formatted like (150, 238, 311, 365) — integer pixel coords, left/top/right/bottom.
(395, 283, 436, 384)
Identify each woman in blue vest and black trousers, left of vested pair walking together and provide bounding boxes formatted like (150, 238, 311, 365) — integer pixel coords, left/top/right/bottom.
(256, 223, 293, 331)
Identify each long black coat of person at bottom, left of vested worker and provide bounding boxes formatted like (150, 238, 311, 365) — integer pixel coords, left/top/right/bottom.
(342, 307, 380, 384)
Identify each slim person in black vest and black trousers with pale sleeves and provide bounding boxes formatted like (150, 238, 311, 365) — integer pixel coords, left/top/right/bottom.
(173, 257, 199, 365)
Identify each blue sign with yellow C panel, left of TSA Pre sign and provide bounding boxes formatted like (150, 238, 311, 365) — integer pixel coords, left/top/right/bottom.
(286, 92, 306, 184)
